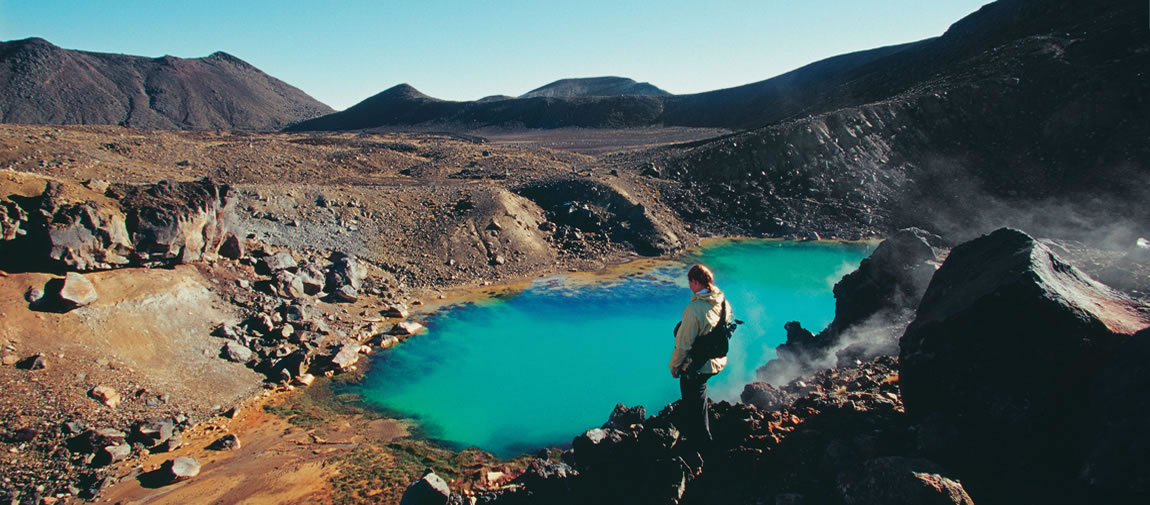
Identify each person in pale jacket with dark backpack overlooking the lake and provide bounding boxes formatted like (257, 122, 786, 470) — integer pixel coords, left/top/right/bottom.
(670, 265, 734, 449)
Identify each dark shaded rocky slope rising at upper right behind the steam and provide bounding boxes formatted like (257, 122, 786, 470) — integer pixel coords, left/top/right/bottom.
(629, 1, 1150, 240)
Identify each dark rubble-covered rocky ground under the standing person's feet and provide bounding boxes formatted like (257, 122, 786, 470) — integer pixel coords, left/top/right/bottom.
(481, 357, 952, 505)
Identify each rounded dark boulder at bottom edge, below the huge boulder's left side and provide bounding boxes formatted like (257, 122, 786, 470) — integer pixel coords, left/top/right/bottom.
(838, 457, 974, 505)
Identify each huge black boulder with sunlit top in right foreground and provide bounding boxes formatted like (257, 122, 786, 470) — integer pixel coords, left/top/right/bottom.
(899, 229, 1150, 504)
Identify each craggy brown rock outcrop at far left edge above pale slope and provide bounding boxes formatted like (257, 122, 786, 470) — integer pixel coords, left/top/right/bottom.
(0, 176, 235, 271)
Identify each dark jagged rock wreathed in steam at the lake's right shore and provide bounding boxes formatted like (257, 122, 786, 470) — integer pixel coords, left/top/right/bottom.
(758, 228, 946, 384)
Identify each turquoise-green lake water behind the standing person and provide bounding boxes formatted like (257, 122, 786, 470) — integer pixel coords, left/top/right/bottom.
(351, 240, 871, 457)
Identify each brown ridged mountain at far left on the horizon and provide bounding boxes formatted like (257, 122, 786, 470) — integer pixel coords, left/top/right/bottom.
(0, 38, 331, 130)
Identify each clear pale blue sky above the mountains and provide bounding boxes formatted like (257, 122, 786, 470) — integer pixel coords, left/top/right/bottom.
(0, 0, 987, 109)
